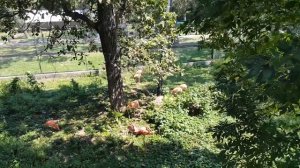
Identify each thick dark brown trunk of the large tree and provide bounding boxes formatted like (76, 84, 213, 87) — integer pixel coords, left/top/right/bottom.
(97, 3, 123, 110)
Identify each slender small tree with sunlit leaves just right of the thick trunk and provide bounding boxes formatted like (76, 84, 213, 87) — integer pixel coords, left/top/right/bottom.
(122, 1, 179, 95)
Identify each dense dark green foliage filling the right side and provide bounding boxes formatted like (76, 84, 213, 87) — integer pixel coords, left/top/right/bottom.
(186, 0, 300, 167)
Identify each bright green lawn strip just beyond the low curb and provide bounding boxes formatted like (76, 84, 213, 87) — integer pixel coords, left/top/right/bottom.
(0, 44, 210, 76)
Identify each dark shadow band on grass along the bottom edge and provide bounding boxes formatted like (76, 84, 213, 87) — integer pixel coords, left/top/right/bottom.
(0, 133, 219, 168)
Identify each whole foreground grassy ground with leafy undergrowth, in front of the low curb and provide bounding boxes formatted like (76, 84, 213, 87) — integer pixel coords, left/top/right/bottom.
(0, 64, 224, 167)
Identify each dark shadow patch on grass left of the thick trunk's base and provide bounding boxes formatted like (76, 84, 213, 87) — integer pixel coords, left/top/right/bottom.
(0, 79, 107, 136)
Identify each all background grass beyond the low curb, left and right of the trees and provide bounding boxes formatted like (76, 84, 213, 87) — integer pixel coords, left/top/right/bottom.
(0, 33, 210, 76)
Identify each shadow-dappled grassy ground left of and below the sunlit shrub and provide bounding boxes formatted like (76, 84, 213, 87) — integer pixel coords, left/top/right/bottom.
(0, 78, 219, 168)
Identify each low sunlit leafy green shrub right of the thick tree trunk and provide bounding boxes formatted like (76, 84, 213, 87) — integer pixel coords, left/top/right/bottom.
(146, 84, 220, 146)
